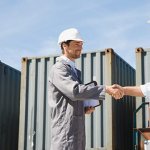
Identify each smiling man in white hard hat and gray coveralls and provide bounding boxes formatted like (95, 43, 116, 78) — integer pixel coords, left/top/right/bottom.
(48, 28, 123, 150)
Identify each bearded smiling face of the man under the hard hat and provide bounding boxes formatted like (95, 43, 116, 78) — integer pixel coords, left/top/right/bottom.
(64, 41, 83, 60)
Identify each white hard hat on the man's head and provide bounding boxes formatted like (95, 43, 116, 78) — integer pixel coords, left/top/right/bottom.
(58, 28, 83, 45)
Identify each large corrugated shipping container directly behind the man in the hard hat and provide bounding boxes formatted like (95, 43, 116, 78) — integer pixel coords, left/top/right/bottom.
(19, 49, 135, 150)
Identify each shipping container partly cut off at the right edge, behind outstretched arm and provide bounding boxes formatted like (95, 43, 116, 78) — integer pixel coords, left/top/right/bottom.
(135, 47, 150, 128)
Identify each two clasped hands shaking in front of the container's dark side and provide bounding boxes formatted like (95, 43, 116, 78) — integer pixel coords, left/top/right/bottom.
(106, 84, 125, 99)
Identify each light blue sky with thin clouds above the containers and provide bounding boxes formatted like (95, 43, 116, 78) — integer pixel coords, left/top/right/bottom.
(0, 0, 150, 70)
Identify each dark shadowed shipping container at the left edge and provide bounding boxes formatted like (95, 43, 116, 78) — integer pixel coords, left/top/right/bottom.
(0, 61, 21, 150)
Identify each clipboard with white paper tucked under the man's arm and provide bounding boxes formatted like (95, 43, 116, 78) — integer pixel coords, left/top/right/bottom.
(84, 81, 102, 107)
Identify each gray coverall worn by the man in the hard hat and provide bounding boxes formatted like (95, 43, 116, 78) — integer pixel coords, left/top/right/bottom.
(48, 57, 105, 150)
